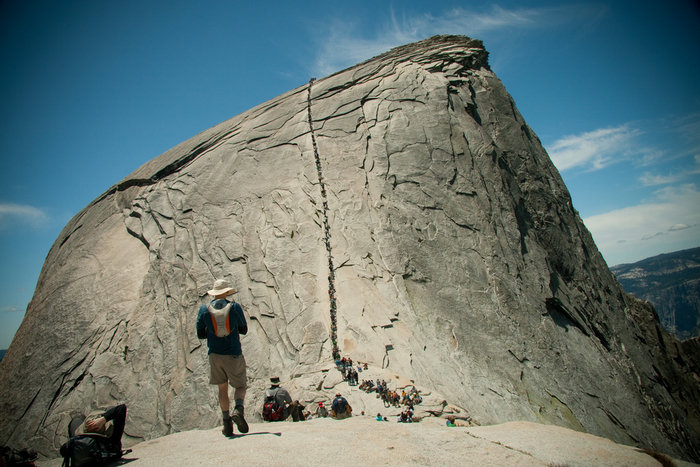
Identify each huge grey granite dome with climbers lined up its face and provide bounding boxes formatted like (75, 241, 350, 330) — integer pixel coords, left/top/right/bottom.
(0, 36, 700, 461)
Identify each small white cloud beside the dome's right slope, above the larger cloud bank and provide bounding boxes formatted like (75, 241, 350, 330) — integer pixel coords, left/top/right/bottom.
(546, 124, 649, 171)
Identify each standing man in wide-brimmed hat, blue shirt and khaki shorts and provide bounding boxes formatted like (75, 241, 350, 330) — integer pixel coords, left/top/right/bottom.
(197, 279, 248, 437)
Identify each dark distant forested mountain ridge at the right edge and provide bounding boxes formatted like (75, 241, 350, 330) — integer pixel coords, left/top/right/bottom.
(610, 247, 700, 340)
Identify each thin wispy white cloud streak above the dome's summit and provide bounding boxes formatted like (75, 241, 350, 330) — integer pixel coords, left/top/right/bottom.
(313, 5, 600, 77)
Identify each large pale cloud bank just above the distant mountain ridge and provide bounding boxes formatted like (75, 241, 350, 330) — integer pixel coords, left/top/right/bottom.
(584, 184, 700, 265)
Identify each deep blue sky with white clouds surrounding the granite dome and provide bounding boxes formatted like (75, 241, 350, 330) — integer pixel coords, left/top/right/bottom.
(0, 0, 700, 348)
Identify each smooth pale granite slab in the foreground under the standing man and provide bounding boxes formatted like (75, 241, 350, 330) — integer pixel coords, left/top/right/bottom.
(38, 417, 696, 467)
